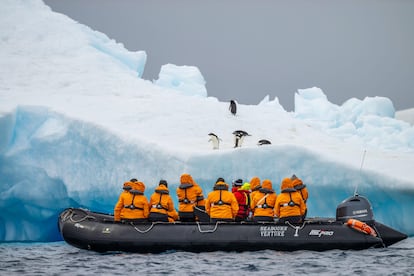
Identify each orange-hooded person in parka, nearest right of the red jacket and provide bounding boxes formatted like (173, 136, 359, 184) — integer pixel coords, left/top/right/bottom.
(250, 179, 277, 221)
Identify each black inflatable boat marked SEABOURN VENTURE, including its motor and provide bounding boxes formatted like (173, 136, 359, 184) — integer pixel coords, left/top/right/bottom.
(58, 195, 407, 253)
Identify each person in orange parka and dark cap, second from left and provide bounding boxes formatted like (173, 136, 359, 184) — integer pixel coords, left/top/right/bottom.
(148, 180, 175, 222)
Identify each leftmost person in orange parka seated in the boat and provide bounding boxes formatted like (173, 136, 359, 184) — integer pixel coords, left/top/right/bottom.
(114, 181, 149, 222)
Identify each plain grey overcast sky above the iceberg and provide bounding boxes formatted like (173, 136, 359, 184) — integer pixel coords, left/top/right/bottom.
(44, 0, 414, 110)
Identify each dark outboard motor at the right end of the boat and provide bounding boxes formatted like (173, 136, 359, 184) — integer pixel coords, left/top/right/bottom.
(336, 195, 374, 223)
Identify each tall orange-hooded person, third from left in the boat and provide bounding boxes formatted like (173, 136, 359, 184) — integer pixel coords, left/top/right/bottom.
(176, 173, 204, 221)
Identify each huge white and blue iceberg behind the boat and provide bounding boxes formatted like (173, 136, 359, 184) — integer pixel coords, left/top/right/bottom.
(0, 0, 414, 241)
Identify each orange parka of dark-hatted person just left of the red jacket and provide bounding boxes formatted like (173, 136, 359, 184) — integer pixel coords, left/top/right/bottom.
(206, 181, 239, 219)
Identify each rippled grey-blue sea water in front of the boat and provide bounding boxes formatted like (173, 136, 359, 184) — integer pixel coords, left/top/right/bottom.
(0, 237, 414, 276)
